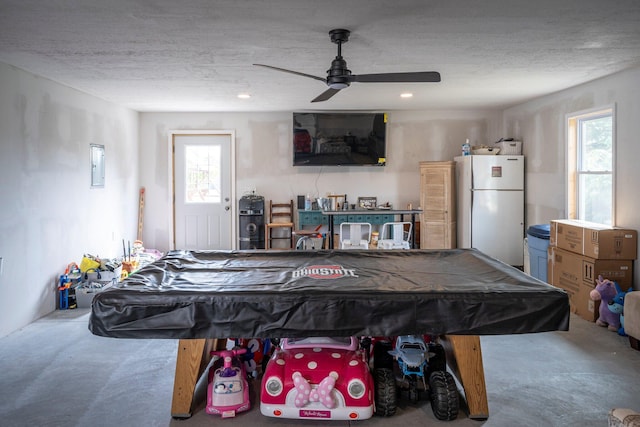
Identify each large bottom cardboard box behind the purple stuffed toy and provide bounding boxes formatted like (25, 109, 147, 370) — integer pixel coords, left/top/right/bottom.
(547, 246, 633, 322)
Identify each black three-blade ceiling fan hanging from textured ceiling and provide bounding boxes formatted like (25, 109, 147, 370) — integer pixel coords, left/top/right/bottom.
(253, 29, 440, 102)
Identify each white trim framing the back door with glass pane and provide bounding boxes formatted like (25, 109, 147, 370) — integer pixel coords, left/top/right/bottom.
(167, 129, 238, 250)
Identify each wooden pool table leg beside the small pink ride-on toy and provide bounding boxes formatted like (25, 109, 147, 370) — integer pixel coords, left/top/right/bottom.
(171, 339, 218, 418)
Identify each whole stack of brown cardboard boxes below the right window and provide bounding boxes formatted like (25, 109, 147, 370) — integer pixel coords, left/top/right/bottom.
(547, 219, 638, 322)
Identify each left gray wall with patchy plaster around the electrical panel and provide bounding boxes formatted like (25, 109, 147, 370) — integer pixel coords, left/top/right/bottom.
(0, 63, 139, 336)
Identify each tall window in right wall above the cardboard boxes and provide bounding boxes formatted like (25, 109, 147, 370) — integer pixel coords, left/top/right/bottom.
(567, 108, 615, 225)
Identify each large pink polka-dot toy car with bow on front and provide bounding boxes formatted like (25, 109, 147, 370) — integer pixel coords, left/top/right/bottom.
(260, 337, 375, 420)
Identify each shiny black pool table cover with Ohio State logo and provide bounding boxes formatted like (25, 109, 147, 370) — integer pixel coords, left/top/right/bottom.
(89, 249, 570, 339)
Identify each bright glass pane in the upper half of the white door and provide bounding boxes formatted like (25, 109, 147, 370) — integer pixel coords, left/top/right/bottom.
(185, 145, 221, 203)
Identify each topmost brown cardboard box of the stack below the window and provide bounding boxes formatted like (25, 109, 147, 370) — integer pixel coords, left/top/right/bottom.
(549, 219, 638, 260)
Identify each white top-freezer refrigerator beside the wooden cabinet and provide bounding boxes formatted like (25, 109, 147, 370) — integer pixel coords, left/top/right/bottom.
(455, 155, 524, 266)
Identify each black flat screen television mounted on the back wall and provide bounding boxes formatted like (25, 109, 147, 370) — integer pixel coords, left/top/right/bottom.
(293, 112, 387, 166)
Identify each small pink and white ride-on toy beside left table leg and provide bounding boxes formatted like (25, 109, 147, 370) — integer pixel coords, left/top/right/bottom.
(205, 348, 251, 418)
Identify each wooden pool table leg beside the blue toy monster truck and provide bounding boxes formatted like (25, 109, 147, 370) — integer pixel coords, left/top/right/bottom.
(441, 335, 489, 420)
